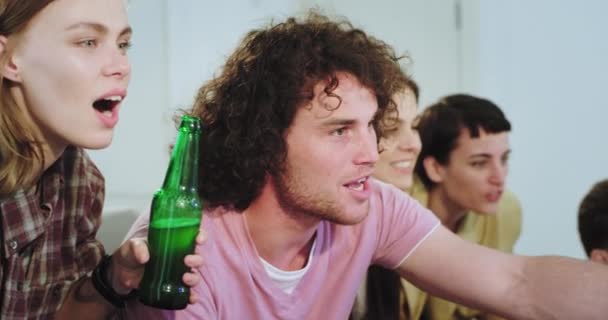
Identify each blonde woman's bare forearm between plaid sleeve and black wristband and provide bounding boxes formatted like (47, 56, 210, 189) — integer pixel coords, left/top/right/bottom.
(55, 277, 121, 320)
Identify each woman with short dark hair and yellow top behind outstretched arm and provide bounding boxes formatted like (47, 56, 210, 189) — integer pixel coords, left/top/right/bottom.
(356, 94, 521, 320)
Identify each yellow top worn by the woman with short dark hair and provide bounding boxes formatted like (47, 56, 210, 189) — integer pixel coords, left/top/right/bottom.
(400, 179, 521, 320)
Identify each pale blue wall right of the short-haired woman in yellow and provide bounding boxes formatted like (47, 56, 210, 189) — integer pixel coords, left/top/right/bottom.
(478, 0, 608, 257)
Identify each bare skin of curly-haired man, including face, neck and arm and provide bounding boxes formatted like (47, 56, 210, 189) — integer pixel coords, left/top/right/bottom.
(245, 74, 608, 319)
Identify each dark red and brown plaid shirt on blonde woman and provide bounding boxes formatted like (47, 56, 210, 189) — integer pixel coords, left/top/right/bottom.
(0, 147, 104, 320)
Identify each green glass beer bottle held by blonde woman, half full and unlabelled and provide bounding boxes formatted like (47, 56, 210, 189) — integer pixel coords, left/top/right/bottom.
(138, 116, 202, 310)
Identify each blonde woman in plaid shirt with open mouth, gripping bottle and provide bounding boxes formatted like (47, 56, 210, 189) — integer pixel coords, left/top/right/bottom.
(0, 0, 200, 319)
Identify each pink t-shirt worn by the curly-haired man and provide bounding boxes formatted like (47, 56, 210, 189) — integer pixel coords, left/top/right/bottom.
(127, 180, 439, 320)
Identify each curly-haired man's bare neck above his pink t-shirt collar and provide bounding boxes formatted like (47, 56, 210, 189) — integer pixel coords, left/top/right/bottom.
(243, 184, 320, 271)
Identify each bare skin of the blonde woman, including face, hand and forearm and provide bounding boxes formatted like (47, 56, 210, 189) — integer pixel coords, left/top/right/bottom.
(0, 0, 205, 319)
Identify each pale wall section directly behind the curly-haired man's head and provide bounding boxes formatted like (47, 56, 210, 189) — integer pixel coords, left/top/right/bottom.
(168, 0, 463, 108)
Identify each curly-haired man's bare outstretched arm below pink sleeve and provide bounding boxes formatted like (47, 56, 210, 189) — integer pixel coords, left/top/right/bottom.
(398, 227, 608, 320)
